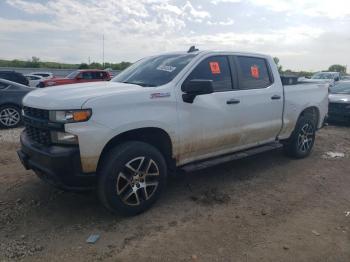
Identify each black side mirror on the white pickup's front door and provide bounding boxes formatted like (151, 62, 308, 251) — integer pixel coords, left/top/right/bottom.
(181, 79, 214, 103)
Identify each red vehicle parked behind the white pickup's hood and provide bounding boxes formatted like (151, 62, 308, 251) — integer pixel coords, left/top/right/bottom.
(38, 69, 111, 87)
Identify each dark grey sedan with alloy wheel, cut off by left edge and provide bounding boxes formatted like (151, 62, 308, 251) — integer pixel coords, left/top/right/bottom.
(0, 79, 34, 128)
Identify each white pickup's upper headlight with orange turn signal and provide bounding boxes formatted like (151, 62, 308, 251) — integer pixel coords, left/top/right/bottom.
(50, 109, 92, 123)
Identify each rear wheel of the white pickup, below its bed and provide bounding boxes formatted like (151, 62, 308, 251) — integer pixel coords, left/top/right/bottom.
(284, 117, 316, 158)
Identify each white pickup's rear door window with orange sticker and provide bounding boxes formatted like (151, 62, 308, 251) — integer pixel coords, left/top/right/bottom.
(235, 56, 273, 90)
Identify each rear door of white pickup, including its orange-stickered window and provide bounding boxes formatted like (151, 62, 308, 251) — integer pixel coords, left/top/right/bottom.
(232, 56, 283, 146)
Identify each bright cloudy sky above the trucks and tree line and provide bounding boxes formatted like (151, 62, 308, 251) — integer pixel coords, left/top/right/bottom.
(0, 0, 350, 71)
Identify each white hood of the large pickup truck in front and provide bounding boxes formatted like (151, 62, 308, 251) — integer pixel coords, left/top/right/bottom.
(23, 81, 144, 110)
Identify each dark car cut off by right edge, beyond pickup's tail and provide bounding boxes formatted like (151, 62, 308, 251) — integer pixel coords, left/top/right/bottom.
(328, 81, 350, 123)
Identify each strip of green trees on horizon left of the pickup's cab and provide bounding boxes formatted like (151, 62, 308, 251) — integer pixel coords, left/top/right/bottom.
(0, 56, 131, 70)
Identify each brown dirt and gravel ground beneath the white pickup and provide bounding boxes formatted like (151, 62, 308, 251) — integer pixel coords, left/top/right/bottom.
(0, 126, 350, 262)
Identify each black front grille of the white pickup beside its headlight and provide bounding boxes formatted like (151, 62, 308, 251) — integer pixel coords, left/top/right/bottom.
(23, 107, 51, 146)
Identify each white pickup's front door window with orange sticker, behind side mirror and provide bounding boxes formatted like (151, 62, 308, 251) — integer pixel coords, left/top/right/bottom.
(185, 55, 233, 92)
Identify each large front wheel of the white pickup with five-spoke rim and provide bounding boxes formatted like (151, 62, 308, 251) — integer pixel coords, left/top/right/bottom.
(98, 141, 167, 215)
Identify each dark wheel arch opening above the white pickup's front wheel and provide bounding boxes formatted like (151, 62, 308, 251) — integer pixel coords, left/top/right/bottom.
(97, 127, 176, 173)
